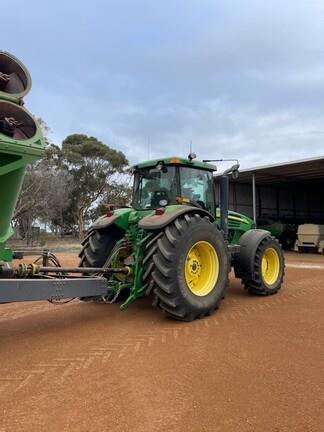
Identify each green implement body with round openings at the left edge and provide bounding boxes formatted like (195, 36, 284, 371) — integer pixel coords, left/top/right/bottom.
(0, 51, 45, 261)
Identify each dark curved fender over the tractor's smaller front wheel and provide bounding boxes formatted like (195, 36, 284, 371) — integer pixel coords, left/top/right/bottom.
(233, 229, 271, 279)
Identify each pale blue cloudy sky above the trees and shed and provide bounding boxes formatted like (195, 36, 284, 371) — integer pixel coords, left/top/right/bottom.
(0, 0, 324, 167)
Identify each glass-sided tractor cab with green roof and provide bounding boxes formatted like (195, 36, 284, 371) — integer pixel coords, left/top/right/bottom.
(133, 158, 216, 215)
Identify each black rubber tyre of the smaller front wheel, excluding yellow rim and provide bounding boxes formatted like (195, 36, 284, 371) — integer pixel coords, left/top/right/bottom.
(242, 235, 285, 296)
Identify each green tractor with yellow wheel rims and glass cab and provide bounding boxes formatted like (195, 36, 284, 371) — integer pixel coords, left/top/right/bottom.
(79, 154, 284, 321)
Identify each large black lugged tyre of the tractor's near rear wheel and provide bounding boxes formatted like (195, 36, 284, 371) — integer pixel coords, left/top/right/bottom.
(152, 214, 230, 321)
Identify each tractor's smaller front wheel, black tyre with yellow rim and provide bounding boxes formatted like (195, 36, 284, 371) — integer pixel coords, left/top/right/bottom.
(242, 235, 285, 296)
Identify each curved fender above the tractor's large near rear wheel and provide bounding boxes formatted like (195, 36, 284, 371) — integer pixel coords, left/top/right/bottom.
(138, 206, 215, 231)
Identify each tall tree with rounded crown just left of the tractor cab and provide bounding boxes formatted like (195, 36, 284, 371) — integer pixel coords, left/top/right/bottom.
(62, 134, 128, 237)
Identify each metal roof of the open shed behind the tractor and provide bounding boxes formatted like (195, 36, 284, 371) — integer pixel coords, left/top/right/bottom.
(217, 156, 324, 184)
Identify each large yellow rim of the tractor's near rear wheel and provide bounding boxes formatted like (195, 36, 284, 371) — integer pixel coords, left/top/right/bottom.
(185, 241, 219, 297)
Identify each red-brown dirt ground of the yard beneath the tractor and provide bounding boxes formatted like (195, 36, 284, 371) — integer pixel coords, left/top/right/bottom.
(0, 254, 324, 432)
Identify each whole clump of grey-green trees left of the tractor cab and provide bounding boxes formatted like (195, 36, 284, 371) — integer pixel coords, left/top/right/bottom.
(12, 123, 129, 241)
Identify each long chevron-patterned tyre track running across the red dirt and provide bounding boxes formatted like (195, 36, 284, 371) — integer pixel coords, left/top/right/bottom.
(0, 277, 323, 401)
